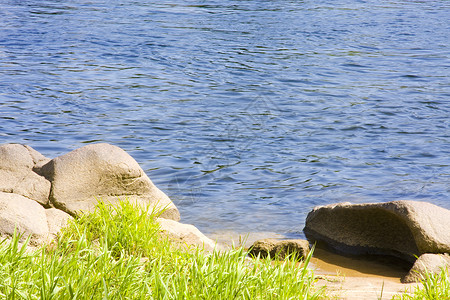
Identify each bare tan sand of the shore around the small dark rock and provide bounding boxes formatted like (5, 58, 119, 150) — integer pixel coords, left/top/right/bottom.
(208, 231, 417, 300)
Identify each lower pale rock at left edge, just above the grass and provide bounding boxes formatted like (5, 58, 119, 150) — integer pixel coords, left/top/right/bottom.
(0, 192, 49, 244)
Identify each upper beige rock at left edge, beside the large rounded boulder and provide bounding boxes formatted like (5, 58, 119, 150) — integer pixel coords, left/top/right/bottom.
(0, 144, 51, 206)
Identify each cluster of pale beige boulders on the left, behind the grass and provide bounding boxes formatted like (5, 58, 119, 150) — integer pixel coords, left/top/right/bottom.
(0, 143, 215, 250)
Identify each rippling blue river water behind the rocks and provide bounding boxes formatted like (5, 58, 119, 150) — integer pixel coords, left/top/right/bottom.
(0, 0, 450, 236)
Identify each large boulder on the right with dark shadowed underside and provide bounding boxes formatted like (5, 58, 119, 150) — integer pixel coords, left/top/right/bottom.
(304, 201, 450, 262)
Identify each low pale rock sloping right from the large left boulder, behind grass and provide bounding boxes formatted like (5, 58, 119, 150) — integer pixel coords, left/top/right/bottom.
(157, 218, 217, 252)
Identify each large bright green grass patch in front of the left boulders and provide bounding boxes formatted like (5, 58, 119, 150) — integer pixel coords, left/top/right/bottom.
(0, 202, 324, 299)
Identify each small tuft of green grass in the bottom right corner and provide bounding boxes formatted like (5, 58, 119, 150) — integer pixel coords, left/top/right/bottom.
(393, 268, 450, 300)
